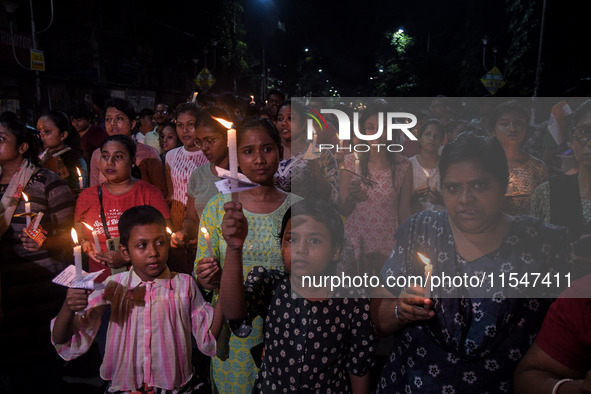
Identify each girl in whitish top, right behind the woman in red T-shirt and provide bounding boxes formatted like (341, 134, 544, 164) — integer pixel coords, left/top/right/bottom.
(166, 103, 210, 230)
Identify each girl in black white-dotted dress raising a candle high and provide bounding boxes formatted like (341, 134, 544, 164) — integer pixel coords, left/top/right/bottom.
(220, 200, 375, 393)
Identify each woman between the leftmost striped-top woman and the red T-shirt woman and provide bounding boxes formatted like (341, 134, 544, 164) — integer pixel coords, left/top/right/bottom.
(37, 110, 88, 191)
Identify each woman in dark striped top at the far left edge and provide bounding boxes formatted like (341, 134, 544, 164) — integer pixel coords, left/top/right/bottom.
(0, 119, 74, 392)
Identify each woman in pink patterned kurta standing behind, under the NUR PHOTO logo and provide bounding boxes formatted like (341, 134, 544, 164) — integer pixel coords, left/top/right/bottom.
(339, 106, 412, 270)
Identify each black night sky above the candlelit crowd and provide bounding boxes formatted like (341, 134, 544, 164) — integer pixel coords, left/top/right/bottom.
(5, 0, 591, 96)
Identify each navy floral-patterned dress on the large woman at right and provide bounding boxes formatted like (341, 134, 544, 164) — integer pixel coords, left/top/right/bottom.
(378, 211, 567, 394)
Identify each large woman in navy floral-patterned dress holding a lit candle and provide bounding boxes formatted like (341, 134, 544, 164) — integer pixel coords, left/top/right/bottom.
(372, 133, 567, 393)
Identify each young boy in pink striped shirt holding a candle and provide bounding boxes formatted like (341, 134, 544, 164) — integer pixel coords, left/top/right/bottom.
(51, 205, 222, 394)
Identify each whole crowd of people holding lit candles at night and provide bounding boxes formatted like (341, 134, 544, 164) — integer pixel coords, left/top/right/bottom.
(0, 91, 591, 394)
